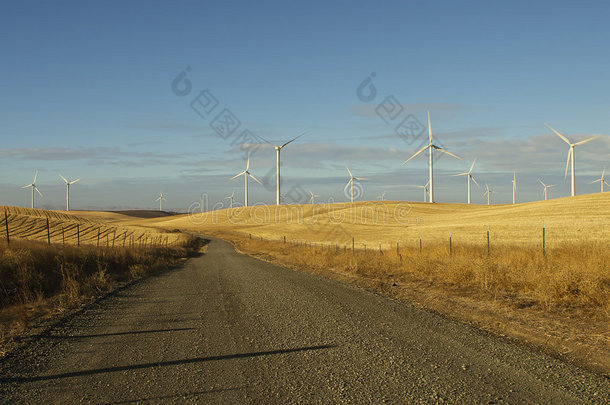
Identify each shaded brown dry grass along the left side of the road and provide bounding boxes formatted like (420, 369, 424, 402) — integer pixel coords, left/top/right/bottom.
(0, 237, 201, 352)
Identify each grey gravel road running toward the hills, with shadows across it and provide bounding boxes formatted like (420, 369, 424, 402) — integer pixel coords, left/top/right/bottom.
(0, 235, 610, 404)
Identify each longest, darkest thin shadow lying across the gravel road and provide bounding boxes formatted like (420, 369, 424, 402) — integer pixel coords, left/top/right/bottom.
(0, 345, 337, 383)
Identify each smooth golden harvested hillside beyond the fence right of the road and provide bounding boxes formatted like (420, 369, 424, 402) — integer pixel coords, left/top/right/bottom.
(144, 193, 610, 250)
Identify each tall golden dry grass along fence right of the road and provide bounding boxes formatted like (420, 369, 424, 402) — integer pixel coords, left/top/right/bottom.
(219, 230, 610, 318)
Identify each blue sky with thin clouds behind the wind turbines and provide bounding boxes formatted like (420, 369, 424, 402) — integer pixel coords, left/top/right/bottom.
(0, 0, 610, 211)
